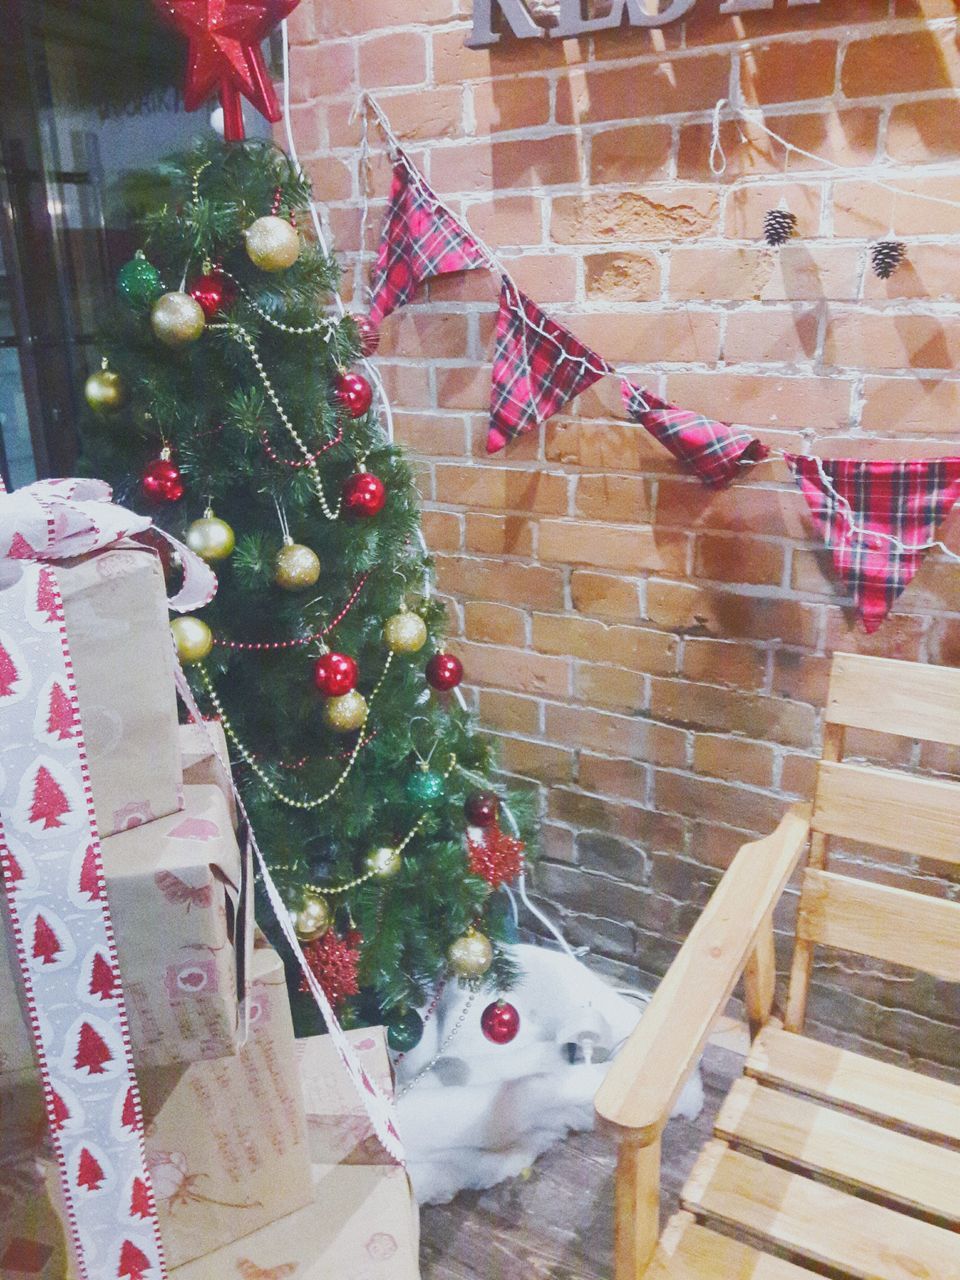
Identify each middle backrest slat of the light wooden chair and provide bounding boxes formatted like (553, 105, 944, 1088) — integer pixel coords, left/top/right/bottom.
(813, 760, 960, 863)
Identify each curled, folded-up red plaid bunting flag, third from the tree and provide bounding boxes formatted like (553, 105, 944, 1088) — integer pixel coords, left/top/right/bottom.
(621, 378, 769, 489)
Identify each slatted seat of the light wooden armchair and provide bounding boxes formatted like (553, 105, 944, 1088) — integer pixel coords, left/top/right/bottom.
(665, 1027, 960, 1280)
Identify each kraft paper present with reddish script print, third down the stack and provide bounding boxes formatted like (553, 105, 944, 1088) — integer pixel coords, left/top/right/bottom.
(0, 948, 316, 1280)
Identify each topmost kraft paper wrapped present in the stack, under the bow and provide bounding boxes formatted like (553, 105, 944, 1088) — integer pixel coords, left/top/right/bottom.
(57, 541, 182, 838)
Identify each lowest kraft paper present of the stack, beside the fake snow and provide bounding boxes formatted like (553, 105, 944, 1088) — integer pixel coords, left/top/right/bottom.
(173, 1027, 420, 1280)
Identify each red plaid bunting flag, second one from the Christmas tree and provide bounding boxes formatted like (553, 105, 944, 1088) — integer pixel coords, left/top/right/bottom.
(486, 278, 613, 453)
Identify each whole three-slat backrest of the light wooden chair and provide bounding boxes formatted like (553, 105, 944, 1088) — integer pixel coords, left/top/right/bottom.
(785, 653, 960, 1032)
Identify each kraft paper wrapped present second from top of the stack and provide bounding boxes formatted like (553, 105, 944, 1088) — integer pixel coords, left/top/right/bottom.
(0, 786, 253, 1075)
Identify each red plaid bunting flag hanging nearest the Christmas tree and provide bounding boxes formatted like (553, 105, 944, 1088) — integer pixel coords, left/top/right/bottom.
(370, 152, 488, 324)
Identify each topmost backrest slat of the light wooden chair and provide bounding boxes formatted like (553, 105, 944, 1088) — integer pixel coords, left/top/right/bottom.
(826, 653, 960, 746)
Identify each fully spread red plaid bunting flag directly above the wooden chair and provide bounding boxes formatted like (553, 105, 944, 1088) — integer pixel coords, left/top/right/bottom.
(786, 453, 960, 632)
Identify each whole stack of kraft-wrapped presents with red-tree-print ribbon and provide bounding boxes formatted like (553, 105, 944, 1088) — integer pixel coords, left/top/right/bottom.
(0, 491, 419, 1280)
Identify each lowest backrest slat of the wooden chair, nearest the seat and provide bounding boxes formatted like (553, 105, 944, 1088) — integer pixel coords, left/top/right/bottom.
(796, 869, 960, 982)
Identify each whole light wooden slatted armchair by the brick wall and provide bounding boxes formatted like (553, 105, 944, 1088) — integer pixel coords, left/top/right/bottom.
(596, 654, 960, 1280)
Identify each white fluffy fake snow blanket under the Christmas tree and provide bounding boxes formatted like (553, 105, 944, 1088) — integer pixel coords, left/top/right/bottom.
(397, 946, 703, 1204)
